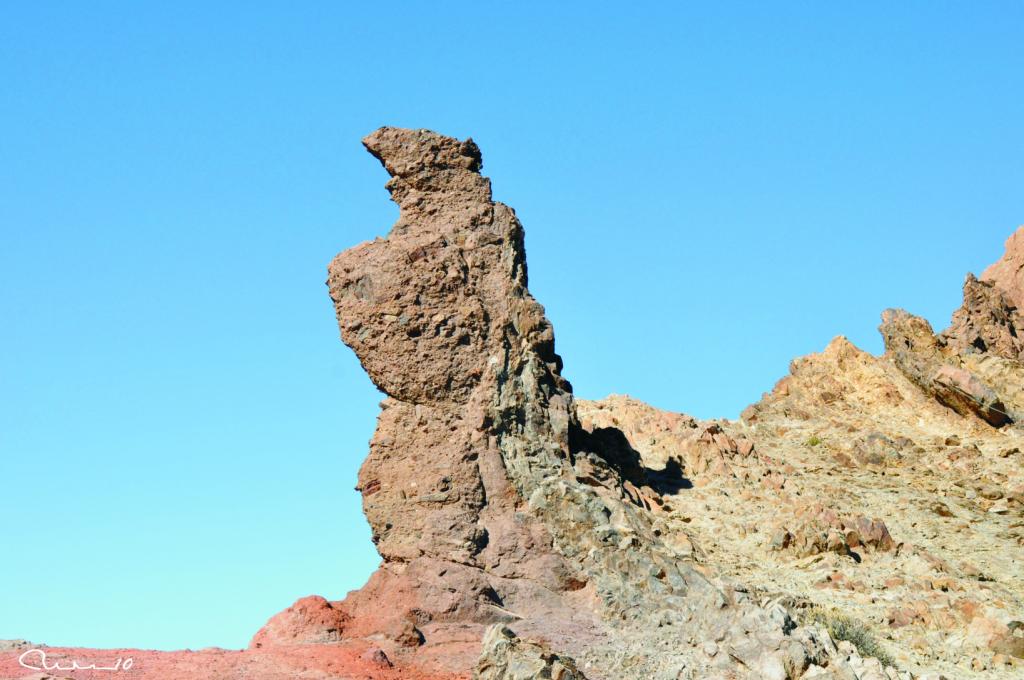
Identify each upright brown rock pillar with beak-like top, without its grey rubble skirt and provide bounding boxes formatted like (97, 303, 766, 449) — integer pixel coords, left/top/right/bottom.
(328, 128, 584, 667)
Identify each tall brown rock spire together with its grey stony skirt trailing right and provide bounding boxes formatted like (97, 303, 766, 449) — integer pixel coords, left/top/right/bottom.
(315, 128, 843, 678)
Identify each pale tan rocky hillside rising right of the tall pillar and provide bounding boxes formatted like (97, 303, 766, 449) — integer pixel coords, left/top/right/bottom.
(579, 227, 1024, 678)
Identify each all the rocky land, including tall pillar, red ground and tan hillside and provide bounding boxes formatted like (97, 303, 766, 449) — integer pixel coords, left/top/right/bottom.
(0, 128, 1024, 680)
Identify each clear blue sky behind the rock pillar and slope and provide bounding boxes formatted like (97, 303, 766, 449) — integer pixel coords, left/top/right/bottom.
(0, 1, 1024, 648)
